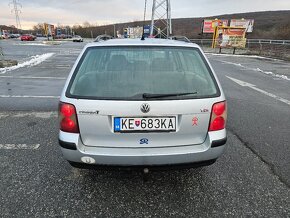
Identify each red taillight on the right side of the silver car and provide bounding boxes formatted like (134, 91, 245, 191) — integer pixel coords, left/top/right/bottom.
(209, 101, 227, 131)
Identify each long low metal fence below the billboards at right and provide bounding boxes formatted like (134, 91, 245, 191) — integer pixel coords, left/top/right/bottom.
(190, 39, 290, 60)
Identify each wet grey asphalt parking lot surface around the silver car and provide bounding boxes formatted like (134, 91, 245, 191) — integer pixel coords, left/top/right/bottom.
(0, 40, 290, 217)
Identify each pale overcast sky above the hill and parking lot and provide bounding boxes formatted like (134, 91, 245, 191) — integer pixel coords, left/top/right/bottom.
(0, 0, 290, 29)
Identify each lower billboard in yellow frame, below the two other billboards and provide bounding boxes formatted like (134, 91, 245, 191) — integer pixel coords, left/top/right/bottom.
(215, 27, 247, 48)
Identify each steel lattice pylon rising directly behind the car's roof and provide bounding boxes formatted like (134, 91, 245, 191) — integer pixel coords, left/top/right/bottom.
(150, 0, 172, 38)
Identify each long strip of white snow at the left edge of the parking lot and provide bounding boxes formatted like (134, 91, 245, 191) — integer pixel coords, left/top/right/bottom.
(0, 53, 54, 74)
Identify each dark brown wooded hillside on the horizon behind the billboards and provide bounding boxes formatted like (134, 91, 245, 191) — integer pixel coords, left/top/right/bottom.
(76, 10, 290, 40)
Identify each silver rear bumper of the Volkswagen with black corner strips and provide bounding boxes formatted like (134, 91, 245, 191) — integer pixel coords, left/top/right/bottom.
(59, 130, 226, 166)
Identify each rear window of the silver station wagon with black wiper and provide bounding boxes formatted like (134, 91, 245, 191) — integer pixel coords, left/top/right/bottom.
(66, 46, 219, 100)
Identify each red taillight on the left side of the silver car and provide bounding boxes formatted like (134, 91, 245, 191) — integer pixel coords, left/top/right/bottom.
(59, 102, 80, 133)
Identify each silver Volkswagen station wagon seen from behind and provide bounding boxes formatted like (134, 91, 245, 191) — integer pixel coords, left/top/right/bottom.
(59, 39, 227, 167)
